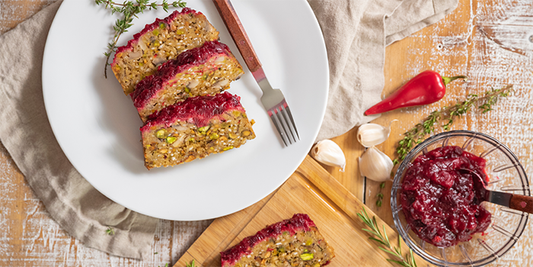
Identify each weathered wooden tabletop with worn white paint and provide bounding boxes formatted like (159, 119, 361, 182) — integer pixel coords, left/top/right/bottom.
(0, 0, 533, 266)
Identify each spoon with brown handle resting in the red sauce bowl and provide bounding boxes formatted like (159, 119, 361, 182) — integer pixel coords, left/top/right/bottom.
(460, 169, 533, 216)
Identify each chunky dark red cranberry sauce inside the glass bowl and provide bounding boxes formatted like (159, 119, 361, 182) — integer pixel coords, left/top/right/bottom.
(400, 146, 491, 247)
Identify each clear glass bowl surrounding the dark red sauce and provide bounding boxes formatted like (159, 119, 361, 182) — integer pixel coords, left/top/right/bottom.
(391, 130, 531, 266)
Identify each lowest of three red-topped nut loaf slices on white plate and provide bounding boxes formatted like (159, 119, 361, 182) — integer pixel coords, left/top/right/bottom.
(141, 92, 255, 169)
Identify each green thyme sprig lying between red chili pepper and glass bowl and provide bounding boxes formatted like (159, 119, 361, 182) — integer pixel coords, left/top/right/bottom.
(393, 85, 513, 165)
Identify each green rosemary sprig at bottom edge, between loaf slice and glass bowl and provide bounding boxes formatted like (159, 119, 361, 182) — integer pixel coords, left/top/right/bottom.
(357, 207, 417, 267)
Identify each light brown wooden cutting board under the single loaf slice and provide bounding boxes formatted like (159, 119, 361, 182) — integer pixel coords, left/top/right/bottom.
(174, 156, 423, 267)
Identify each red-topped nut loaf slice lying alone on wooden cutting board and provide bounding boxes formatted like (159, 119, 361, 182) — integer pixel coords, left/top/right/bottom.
(220, 213, 335, 267)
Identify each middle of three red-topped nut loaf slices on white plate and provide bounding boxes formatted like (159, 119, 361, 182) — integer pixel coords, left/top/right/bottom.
(131, 41, 244, 122)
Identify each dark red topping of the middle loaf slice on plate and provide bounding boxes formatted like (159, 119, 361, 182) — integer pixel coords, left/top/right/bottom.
(131, 41, 230, 108)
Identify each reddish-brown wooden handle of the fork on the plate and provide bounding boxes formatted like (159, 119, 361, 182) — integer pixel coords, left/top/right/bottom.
(213, 0, 261, 72)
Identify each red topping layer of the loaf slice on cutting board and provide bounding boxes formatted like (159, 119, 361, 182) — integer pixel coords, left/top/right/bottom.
(220, 213, 316, 266)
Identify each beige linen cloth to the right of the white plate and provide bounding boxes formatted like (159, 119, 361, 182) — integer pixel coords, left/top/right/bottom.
(308, 0, 458, 141)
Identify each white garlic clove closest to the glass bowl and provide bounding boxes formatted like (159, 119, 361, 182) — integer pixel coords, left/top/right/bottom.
(359, 147, 394, 182)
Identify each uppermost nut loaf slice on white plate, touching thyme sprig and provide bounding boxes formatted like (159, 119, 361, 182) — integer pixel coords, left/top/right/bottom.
(111, 8, 219, 95)
